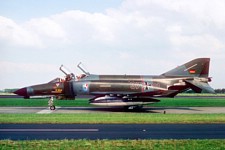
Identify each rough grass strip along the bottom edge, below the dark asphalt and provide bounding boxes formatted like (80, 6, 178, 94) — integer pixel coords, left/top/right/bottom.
(0, 139, 225, 150)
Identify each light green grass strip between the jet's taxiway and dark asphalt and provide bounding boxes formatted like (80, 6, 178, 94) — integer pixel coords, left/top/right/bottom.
(0, 113, 225, 124)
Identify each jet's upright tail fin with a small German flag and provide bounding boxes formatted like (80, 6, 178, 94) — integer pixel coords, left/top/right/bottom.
(162, 58, 210, 77)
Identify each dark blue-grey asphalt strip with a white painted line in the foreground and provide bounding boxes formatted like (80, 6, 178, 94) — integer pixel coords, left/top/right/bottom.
(0, 124, 225, 140)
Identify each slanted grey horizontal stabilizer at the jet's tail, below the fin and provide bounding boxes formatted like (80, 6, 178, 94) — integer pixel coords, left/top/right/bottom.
(185, 80, 215, 93)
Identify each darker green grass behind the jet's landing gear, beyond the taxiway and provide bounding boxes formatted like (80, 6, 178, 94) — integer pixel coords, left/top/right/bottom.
(0, 98, 225, 107)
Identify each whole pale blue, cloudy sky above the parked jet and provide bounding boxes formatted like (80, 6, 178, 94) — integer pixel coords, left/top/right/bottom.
(0, 0, 225, 89)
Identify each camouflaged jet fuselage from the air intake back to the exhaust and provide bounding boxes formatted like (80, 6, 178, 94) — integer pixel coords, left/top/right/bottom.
(73, 75, 190, 97)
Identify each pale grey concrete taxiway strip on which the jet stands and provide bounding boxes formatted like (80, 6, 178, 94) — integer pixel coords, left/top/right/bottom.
(0, 107, 225, 114)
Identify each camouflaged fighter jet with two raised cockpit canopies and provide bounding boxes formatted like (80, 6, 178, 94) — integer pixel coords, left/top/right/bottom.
(14, 58, 215, 110)
